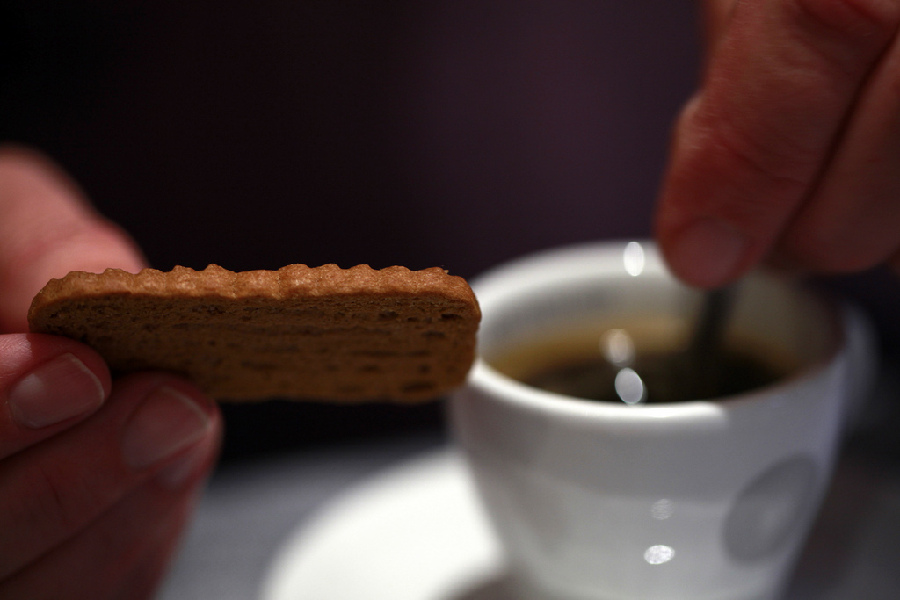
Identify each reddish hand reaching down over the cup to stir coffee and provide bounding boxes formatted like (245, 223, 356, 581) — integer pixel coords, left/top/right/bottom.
(656, 0, 900, 288)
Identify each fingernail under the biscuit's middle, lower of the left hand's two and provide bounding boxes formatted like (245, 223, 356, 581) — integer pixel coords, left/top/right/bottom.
(122, 387, 210, 469)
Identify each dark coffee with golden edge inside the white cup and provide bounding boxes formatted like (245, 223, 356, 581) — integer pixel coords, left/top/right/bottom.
(489, 328, 796, 404)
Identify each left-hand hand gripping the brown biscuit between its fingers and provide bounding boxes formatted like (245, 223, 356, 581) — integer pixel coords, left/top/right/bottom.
(0, 148, 221, 598)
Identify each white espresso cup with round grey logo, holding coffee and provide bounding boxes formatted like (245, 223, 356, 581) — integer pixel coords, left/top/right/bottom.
(450, 242, 875, 600)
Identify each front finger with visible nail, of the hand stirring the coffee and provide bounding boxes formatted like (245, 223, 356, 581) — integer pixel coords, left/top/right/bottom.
(656, 0, 900, 287)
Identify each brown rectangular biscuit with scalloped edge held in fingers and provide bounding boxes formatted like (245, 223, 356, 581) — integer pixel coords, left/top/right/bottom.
(28, 265, 481, 401)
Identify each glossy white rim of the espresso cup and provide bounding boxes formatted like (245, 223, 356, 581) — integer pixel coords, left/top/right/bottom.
(468, 240, 847, 425)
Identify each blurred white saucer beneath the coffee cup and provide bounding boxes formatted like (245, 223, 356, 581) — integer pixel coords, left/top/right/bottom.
(261, 451, 505, 600)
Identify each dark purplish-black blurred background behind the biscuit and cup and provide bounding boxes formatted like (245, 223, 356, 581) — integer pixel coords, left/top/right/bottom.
(0, 0, 900, 459)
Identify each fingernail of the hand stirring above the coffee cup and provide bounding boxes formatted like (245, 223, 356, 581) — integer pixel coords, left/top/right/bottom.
(668, 218, 747, 287)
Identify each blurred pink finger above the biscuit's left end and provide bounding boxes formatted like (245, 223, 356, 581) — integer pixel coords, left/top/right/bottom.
(0, 147, 144, 332)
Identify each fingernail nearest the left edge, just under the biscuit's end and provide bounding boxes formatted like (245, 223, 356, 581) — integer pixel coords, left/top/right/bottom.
(8, 353, 106, 429)
